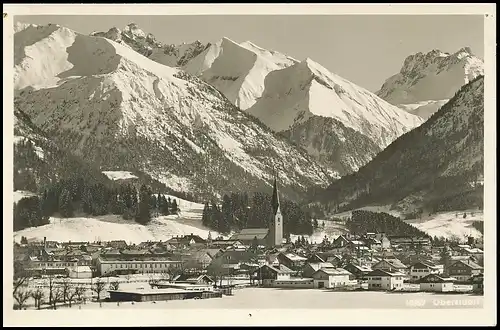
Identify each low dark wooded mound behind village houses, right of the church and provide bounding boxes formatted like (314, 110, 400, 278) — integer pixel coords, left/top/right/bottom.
(345, 210, 429, 237)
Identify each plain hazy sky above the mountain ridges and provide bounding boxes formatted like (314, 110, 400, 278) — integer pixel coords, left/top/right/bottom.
(15, 15, 484, 91)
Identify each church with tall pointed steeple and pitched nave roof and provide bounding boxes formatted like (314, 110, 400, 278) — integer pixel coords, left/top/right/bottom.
(230, 175, 284, 248)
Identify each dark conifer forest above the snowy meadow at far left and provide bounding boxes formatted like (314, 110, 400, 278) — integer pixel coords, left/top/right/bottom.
(14, 177, 179, 230)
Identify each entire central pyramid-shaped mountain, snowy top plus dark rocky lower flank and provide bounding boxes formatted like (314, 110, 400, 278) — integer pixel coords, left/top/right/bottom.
(247, 59, 422, 174)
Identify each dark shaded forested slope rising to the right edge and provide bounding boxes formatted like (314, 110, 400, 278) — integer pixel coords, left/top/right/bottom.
(315, 76, 484, 212)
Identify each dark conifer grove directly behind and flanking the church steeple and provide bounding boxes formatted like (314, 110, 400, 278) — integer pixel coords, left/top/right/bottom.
(202, 192, 318, 237)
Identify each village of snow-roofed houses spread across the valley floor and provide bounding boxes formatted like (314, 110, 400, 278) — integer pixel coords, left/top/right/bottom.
(14, 229, 483, 308)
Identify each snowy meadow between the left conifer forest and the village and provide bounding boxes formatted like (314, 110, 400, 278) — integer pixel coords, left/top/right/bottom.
(14, 196, 223, 243)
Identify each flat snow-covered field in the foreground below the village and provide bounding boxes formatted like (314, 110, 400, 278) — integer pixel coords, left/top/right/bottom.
(45, 288, 483, 309)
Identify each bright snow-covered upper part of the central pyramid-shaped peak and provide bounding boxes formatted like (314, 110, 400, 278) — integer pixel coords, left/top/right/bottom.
(248, 58, 422, 147)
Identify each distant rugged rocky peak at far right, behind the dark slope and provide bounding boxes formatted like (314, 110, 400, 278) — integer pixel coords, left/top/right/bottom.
(376, 47, 484, 119)
